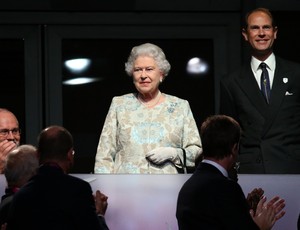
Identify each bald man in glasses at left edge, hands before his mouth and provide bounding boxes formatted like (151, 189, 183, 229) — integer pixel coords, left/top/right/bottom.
(0, 108, 21, 173)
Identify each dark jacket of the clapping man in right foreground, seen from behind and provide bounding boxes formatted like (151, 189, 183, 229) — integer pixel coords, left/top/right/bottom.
(176, 163, 259, 230)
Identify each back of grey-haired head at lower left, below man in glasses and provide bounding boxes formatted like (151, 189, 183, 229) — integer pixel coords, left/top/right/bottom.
(4, 145, 39, 188)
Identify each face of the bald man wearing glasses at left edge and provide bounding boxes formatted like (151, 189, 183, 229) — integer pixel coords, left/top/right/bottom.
(0, 111, 21, 145)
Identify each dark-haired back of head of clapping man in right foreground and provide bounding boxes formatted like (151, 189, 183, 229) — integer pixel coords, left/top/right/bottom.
(200, 115, 241, 159)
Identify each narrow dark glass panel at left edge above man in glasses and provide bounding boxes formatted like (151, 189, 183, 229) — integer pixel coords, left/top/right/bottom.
(0, 39, 26, 143)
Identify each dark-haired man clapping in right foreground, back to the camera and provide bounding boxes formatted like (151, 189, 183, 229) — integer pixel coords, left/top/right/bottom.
(176, 115, 285, 230)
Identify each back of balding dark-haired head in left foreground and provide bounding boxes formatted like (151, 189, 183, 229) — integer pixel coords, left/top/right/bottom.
(38, 126, 73, 163)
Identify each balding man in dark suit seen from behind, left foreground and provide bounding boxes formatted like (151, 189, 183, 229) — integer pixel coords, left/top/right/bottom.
(7, 126, 108, 230)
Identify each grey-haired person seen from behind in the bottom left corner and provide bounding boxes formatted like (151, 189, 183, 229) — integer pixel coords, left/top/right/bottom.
(0, 145, 39, 226)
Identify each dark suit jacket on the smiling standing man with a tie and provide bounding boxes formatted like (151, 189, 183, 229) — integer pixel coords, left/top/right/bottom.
(220, 57, 300, 174)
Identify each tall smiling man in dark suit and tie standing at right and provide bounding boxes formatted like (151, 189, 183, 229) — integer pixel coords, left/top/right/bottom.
(220, 8, 300, 174)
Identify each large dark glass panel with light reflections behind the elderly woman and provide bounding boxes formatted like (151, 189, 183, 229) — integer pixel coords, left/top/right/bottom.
(62, 39, 215, 173)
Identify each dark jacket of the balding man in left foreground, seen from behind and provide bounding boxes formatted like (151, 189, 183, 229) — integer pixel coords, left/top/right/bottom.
(7, 165, 108, 230)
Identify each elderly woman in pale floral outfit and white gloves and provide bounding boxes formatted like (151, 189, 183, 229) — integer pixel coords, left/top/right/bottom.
(94, 43, 202, 174)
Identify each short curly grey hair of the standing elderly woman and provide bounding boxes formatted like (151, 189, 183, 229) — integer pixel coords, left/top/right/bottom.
(125, 43, 171, 77)
